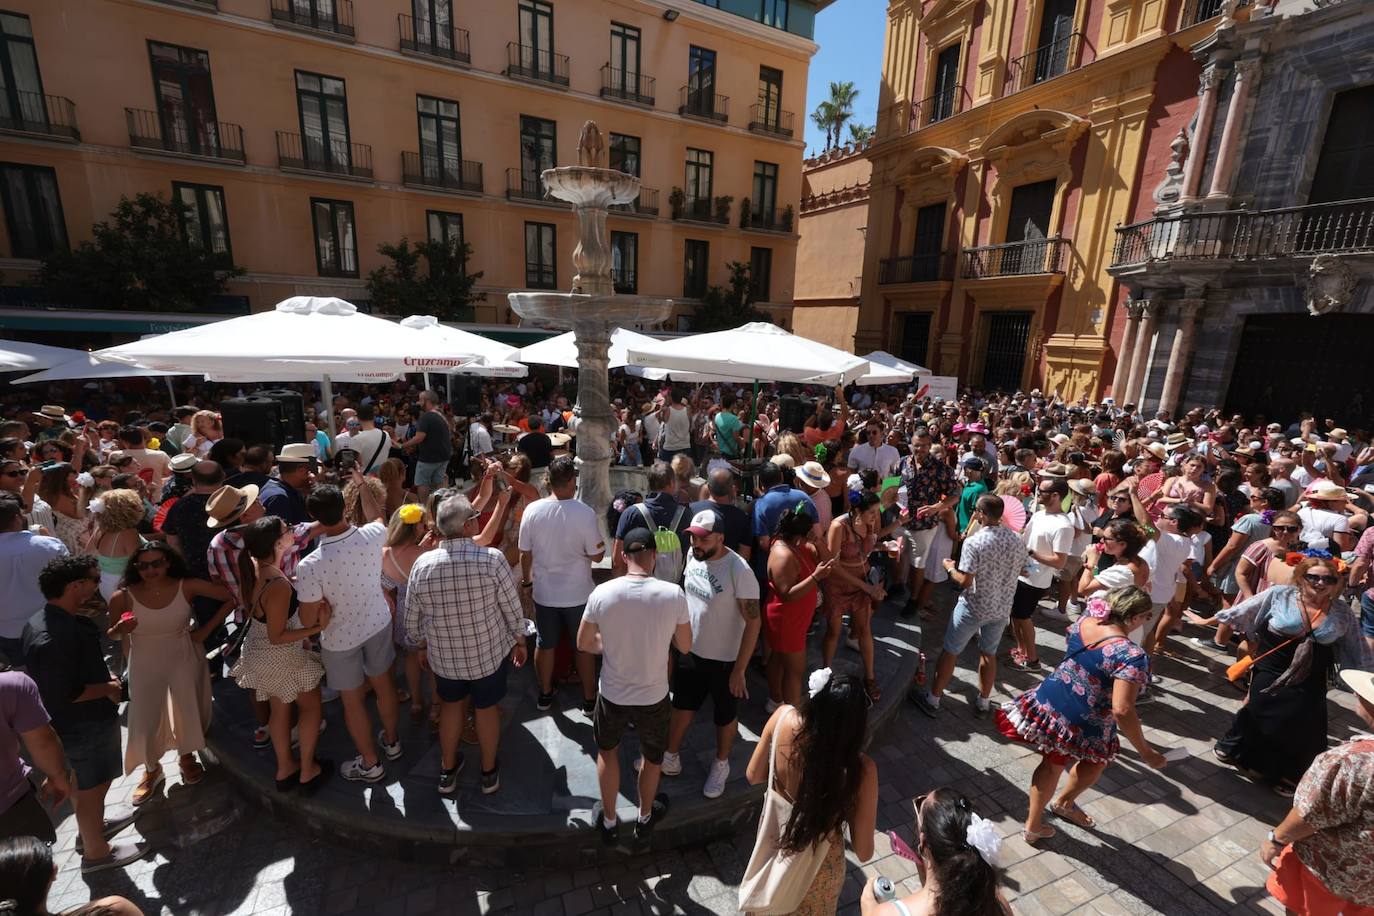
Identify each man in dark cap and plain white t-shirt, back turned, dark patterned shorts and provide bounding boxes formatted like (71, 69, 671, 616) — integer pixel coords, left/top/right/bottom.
(577, 527, 691, 846)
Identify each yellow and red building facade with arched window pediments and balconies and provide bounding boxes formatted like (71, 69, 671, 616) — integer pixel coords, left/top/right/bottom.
(855, 0, 1221, 398)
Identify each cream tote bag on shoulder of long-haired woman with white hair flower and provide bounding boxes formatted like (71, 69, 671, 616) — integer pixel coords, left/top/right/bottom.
(739, 708, 830, 916)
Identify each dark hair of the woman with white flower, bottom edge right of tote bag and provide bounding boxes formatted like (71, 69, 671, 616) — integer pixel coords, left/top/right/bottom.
(916, 788, 1000, 916)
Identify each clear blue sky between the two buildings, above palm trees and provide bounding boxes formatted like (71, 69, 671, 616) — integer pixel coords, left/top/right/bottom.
(797, 0, 888, 155)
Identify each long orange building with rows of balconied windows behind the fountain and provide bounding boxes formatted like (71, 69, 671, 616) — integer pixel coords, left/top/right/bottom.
(0, 0, 830, 343)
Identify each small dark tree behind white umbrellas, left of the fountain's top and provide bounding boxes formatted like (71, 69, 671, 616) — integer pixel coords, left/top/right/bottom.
(367, 238, 486, 321)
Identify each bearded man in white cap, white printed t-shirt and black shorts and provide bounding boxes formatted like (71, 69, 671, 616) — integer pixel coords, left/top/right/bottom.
(664, 509, 763, 798)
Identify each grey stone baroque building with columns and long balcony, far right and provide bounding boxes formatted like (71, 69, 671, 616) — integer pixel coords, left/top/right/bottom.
(1110, 0, 1374, 423)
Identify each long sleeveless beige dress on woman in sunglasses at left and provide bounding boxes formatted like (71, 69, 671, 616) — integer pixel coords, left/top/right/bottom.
(124, 586, 210, 773)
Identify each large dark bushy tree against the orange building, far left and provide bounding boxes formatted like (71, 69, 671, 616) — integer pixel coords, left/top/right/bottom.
(37, 194, 243, 312)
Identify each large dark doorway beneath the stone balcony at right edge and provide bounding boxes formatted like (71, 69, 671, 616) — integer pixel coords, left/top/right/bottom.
(1226, 314, 1374, 427)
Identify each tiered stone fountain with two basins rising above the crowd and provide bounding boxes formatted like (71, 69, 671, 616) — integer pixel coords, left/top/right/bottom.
(508, 121, 673, 516)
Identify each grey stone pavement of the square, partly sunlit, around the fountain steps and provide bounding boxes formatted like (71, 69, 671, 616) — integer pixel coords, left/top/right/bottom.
(40, 593, 1358, 916)
